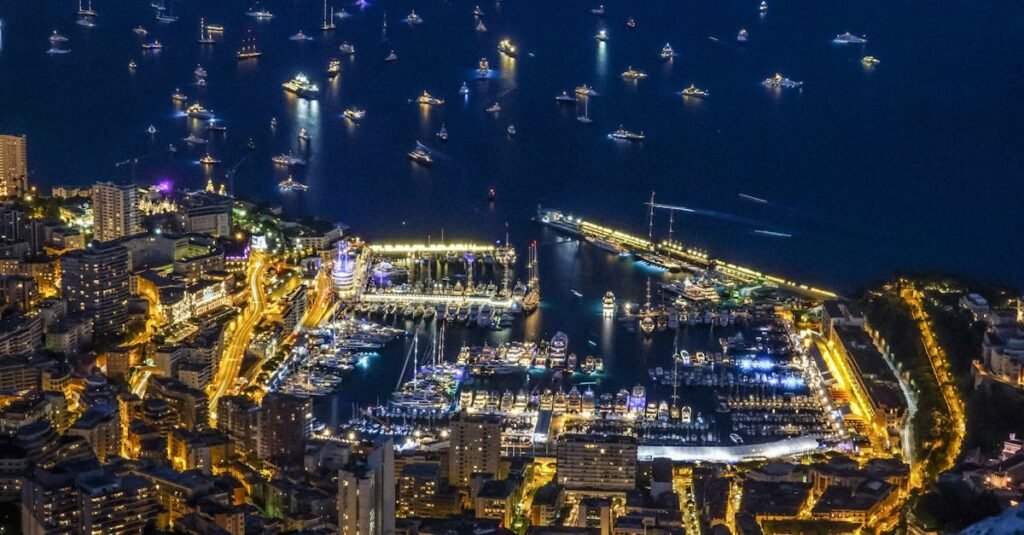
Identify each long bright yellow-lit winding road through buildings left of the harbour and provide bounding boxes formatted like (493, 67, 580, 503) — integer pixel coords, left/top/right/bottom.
(207, 251, 269, 425)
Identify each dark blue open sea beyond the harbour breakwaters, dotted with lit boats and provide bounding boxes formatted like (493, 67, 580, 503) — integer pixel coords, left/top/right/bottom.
(0, 0, 1024, 290)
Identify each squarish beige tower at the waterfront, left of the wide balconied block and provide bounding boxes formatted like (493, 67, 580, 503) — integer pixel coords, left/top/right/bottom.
(449, 415, 502, 488)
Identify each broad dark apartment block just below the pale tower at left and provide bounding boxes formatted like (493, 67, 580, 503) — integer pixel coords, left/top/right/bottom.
(60, 242, 131, 334)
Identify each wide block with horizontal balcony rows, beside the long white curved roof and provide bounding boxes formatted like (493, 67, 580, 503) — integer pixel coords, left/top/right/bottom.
(557, 435, 637, 492)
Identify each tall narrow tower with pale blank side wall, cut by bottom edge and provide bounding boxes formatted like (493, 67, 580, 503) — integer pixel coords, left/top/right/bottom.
(338, 439, 395, 535)
